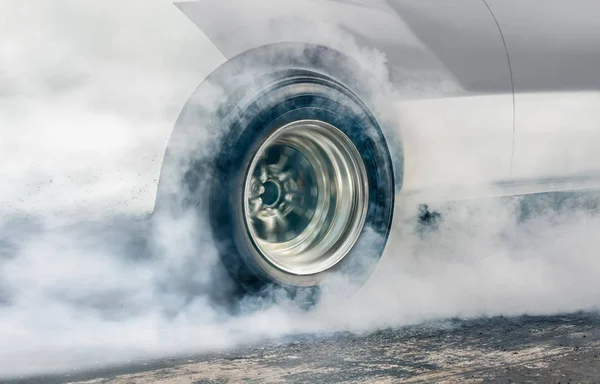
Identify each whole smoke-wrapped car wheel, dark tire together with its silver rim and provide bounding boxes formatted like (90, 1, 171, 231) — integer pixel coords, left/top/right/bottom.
(155, 44, 396, 300)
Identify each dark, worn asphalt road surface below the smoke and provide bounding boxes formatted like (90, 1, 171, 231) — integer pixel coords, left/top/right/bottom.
(9, 313, 600, 384)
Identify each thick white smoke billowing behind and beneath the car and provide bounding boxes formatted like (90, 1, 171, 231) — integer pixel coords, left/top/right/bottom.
(0, 0, 600, 377)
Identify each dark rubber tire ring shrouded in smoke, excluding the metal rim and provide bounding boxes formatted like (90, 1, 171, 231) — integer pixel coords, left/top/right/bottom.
(155, 44, 396, 297)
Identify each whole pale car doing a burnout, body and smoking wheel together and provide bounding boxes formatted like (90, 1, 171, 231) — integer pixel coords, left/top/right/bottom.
(154, 0, 600, 294)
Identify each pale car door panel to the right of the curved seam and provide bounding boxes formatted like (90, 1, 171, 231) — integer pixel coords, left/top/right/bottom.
(487, 0, 600, 184)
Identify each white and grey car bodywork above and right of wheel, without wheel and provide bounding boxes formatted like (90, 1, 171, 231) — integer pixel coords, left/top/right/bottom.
(176, 0, 600, 200)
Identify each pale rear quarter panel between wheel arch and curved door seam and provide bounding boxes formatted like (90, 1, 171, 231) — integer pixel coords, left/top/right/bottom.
(177, 0, 513, 198)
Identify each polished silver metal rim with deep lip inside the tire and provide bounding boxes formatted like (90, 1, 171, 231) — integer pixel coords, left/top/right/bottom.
(243, 120, 369, 275)
